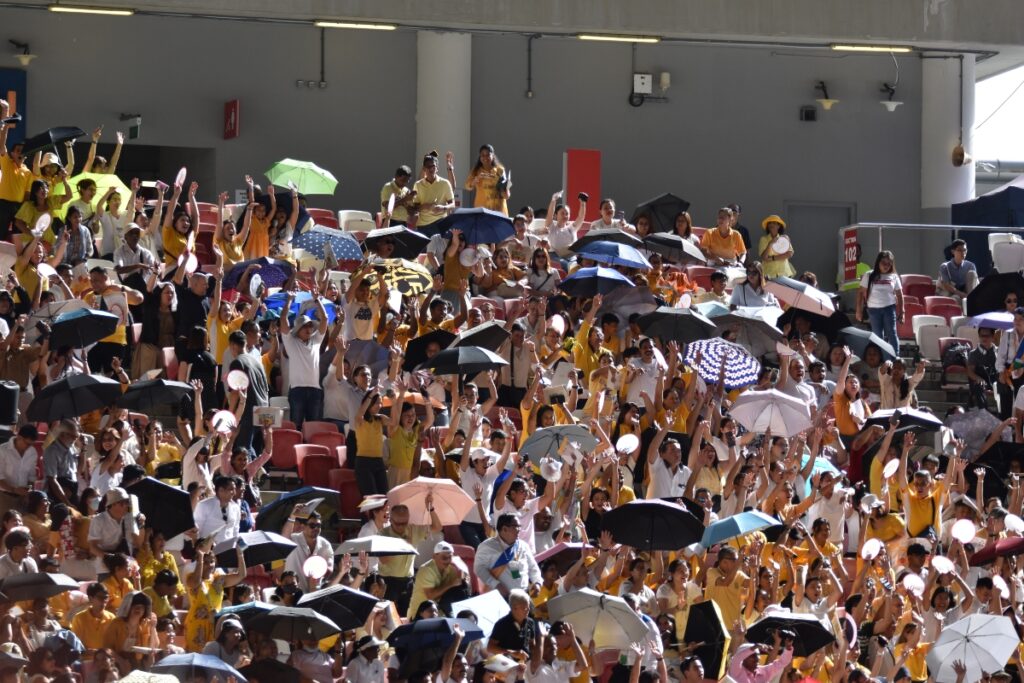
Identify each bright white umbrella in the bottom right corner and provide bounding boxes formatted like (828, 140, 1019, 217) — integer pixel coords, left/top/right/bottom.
(926, 614, 1020, 683)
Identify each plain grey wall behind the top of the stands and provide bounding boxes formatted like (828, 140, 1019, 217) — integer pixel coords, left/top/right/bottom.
(0, 9, 937, 273)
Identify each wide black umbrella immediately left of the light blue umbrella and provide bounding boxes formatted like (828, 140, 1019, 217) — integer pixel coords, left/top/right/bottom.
(601, 500, 705, 550)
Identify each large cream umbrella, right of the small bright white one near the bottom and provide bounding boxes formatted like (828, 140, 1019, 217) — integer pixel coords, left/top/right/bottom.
(548, 588, 649, 650)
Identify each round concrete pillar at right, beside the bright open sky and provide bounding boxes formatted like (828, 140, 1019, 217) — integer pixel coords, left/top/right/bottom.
(921, 54, 974, 223)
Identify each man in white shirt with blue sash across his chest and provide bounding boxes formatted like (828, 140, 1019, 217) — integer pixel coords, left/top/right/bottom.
(473, 513, 541, 595)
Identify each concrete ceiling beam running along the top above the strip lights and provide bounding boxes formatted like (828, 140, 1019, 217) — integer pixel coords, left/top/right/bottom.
(12, 0, 1024, 78)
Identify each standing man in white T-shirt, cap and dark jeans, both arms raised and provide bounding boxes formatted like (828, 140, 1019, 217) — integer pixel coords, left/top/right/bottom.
(281, 289, 327, 429)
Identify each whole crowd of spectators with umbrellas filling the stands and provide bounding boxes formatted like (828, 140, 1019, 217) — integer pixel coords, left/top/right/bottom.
(0, 100, 1024, 683)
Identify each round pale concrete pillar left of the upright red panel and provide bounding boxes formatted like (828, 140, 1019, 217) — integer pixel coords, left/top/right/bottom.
(413, 31, 476, 198)
